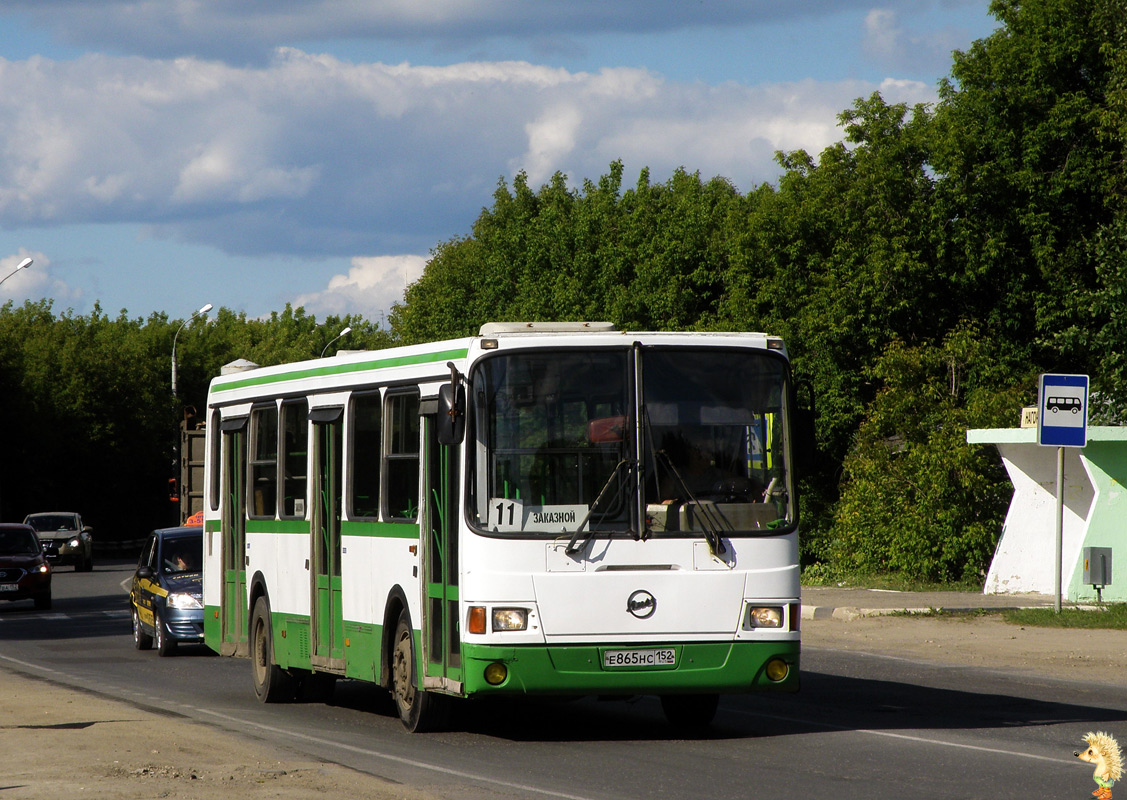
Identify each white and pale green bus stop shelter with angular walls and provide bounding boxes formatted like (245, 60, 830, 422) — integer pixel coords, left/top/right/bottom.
(967, 426, 1127, 603)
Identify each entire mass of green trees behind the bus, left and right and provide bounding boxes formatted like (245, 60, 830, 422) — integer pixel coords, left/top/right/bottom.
(0, 0, 1127, 580)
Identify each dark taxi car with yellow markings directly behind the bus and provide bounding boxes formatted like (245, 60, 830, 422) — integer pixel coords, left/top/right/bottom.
(130, 526, 204, 656)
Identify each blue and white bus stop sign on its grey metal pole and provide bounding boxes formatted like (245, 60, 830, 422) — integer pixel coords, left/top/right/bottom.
(1037, 374, 1088, 614)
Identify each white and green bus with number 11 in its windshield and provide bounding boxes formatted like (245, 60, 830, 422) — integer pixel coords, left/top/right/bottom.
(204, 322, 800, 731)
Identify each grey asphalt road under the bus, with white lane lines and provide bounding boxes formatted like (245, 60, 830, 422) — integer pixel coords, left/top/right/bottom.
(0, 562, 1127, 800)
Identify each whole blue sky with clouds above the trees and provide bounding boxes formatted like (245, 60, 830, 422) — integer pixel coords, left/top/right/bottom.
(0, 0, 996, 320)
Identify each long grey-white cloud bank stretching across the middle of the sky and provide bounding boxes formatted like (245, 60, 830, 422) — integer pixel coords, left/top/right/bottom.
(0, 48, 934, 256)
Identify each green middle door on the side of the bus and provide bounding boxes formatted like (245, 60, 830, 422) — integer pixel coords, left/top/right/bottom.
(310, 409, 345, 672)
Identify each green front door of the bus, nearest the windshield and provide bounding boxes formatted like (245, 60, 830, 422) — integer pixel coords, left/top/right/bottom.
(423, 417, 462, 693)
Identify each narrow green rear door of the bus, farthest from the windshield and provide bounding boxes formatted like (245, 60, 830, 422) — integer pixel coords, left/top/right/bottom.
(220, 419, 249, 656)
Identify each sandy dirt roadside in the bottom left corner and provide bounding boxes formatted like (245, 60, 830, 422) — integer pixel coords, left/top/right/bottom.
(0, 670, 433, 800)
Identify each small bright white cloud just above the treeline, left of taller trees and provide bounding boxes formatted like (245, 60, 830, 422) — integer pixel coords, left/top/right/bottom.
(293, 256, 427, 320)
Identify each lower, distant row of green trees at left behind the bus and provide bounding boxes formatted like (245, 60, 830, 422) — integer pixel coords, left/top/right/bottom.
(0, 301, 389, 542)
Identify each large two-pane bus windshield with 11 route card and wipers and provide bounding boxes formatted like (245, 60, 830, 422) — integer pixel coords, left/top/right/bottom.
(469, 347, 796, 537)
